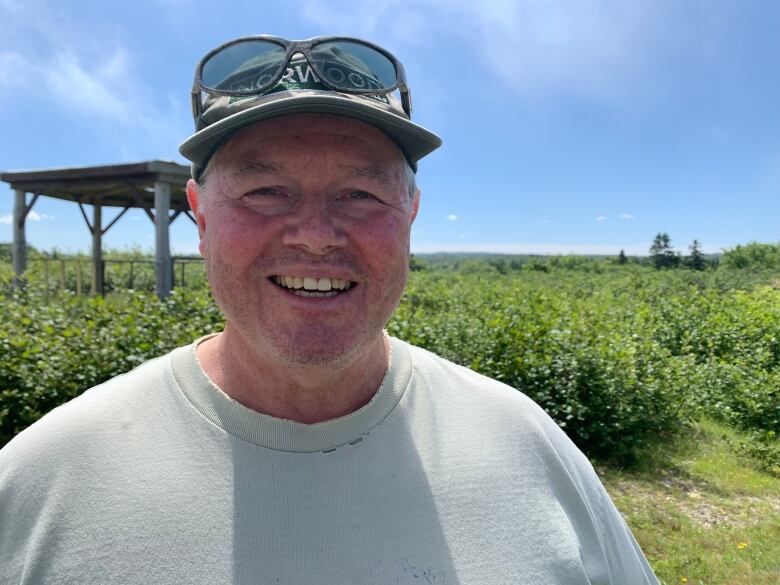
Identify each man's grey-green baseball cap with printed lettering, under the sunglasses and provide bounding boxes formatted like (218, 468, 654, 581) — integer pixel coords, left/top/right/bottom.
(179, 44, 442, 179)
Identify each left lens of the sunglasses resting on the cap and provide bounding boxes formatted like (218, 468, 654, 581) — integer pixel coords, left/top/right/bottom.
(201, 40, 285, 91)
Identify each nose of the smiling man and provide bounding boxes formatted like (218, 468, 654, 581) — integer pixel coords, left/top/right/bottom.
(282, 200, 347, 255)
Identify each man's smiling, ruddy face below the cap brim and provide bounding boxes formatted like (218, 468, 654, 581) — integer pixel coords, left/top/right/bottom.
(188, 114, 418, 364)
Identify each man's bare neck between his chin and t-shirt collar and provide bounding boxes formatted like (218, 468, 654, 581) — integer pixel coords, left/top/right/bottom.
(196, 326, 389, 424)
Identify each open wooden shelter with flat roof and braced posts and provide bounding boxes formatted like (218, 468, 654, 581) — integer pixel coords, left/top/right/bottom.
(0, 160, 195, 297)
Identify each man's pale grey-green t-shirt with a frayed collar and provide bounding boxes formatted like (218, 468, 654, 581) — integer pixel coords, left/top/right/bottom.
(0, 338, 657, 585)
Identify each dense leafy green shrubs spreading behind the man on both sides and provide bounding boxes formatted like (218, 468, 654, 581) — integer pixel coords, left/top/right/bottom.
(0, 257, 780, 469)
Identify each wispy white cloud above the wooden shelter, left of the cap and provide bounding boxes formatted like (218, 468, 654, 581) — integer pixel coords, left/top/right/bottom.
(0, 0, 191, 158)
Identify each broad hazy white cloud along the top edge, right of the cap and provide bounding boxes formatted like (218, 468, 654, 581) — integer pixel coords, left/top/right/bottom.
(300, 0, 727, 103)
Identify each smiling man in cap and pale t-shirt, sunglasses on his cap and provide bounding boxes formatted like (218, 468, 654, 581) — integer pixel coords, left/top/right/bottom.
(0, 37, 657, 585)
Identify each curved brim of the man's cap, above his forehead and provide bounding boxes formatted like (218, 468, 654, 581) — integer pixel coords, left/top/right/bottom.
(179, 92, 441, 173)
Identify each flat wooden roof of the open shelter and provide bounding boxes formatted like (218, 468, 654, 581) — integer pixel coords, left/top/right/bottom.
(0, 160, 191, 210)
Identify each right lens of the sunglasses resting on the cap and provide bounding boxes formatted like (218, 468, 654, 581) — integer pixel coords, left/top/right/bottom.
(311, 41, 397, 90)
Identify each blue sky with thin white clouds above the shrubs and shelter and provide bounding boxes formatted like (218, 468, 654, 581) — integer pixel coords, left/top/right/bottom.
(0, 0, 780, 255)
